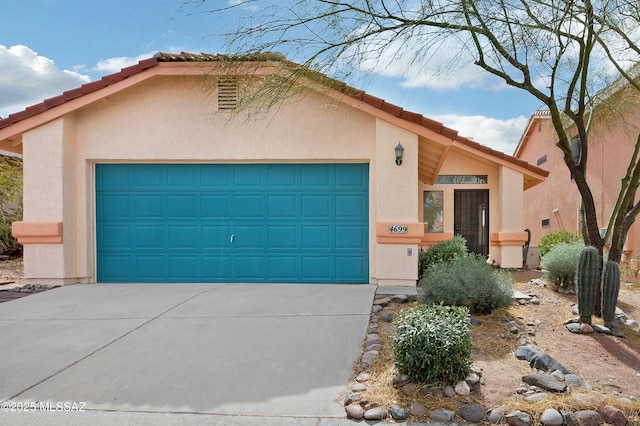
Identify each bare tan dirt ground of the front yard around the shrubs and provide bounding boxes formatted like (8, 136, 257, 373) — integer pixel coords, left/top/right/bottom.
(356, 271, 640, 424)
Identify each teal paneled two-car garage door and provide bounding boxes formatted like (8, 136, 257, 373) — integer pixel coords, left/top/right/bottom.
(96, 164, 369, 283)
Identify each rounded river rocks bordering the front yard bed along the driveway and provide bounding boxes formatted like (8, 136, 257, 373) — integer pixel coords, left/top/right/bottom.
(343, 294, 632, 426)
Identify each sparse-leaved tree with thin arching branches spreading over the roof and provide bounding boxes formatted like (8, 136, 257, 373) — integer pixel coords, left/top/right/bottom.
(184, 0, 640, 311)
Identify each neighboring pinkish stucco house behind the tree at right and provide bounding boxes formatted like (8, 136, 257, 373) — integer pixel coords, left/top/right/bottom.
(514, 91, 640, 267)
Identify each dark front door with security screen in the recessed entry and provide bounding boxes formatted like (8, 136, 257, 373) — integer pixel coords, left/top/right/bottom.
(453, 189, 489, 256)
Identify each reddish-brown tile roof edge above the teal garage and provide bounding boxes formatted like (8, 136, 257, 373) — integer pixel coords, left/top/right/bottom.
(0, 52, 549, 176)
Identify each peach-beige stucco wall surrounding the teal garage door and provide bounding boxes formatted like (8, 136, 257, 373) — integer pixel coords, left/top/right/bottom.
(16, 77, 418, 285)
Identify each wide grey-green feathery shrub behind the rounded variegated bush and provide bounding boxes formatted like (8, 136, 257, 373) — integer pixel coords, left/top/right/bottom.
(418, 254, 513, 314)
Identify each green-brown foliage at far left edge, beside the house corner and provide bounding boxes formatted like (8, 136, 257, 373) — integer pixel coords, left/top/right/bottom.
(0, 156, 22, 255)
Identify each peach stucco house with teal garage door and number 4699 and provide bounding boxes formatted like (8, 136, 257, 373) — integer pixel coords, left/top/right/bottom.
(0, 53, 547, 285)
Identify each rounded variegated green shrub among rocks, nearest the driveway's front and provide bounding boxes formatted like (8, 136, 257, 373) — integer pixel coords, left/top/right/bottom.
(393, 305, 472, 384)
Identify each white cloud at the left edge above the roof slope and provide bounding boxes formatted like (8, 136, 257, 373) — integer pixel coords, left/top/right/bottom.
(0, 45, 90, 117)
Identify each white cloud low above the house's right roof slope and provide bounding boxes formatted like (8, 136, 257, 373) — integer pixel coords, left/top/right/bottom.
(430, 114, 529, 155)
